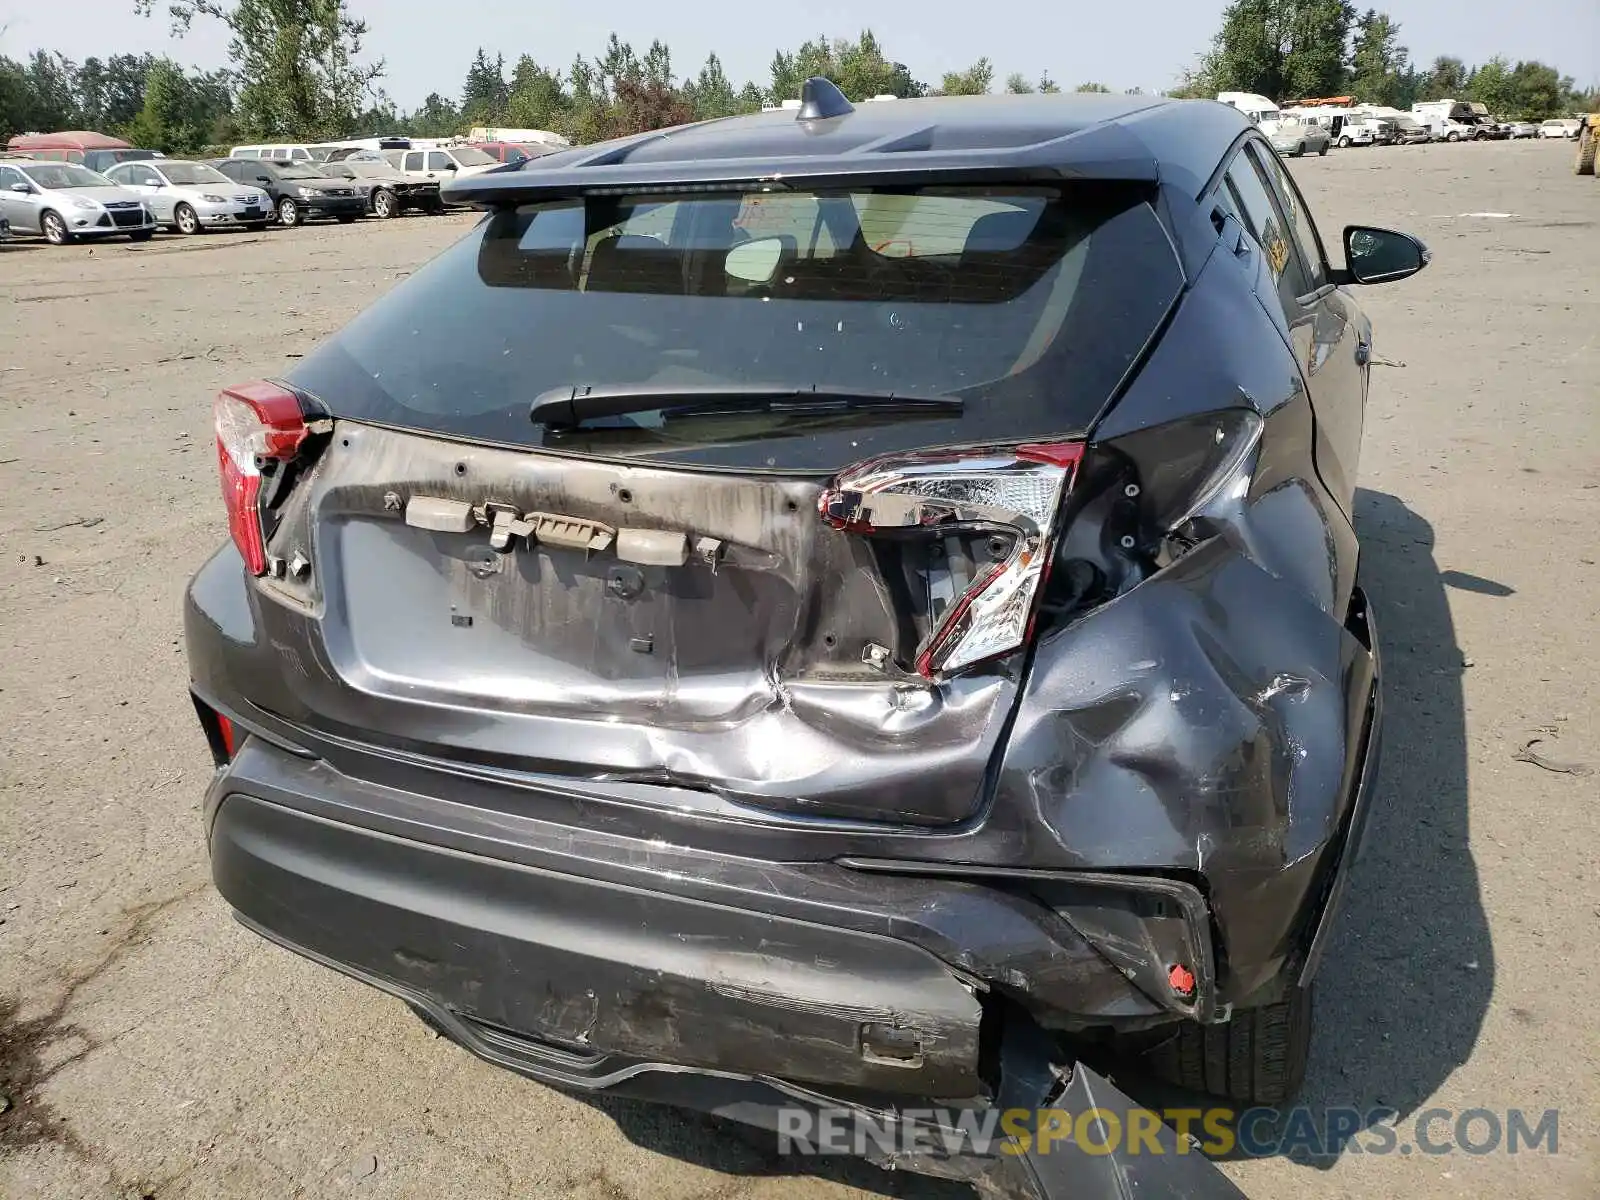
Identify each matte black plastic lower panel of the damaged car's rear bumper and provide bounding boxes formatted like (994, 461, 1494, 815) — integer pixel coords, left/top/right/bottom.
(211, 795, 982, 1096)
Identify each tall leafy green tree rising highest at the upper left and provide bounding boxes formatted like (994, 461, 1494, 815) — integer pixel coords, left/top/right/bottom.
(134, 0, 384, 139)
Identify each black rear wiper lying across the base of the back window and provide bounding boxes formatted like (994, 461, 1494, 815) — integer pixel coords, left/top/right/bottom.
(528, 384, 965, 429)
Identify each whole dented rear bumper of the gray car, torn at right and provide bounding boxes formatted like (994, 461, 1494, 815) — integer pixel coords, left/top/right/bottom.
(208, 752, 1238, 1200)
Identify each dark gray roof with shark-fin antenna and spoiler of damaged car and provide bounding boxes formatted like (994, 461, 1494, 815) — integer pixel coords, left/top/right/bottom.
(446, 91, 1251, 203)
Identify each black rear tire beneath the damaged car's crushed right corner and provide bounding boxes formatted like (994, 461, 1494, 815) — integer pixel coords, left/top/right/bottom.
(1146, 987, 1312, 1107)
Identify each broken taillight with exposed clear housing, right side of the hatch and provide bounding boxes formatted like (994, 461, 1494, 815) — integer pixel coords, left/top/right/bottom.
(818, 442, 1083, 678)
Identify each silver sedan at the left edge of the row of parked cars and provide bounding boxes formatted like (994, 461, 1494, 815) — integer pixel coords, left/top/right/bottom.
(0, 158, 155, 246)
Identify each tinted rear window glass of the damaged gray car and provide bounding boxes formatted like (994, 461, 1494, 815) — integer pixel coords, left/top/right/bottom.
(290, 184, 1182, 467)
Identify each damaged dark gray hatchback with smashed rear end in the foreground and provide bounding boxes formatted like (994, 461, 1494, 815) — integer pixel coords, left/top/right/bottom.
(186, 80, 1427, 1195)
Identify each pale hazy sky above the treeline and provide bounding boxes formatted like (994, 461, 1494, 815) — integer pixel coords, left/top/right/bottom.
(0, 0, 1600, 109)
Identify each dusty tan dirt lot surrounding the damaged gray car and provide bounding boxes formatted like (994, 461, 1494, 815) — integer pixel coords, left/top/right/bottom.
(0, 142, 1600, 1200)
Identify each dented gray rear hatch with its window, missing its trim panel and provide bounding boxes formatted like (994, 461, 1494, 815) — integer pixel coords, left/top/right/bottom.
(218, 173, 1181, 826)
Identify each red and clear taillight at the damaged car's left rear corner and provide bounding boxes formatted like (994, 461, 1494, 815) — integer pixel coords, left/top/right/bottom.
(213, 382, 306, 574)
